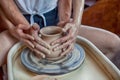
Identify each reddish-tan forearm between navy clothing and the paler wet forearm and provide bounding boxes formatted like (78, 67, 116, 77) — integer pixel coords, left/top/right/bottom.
(58, 0, 72, 22)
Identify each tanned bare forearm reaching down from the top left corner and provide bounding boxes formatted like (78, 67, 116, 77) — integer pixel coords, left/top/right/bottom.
(0, 0, 29, 26)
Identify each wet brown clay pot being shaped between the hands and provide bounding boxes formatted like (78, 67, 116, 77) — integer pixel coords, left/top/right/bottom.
(40, 26, 63, 60)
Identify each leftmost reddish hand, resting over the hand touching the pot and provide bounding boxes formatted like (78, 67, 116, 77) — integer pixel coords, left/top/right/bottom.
(9, 24, 34, 48)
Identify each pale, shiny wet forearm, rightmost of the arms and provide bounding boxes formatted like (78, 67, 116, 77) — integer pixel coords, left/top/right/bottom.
(73, 0, 84, 25)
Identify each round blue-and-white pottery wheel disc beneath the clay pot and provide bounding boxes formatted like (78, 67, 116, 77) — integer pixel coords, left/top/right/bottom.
(21, 44, 85, 75)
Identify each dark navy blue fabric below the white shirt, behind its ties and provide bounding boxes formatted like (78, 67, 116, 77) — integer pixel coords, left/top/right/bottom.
(24, 8, 59, 28)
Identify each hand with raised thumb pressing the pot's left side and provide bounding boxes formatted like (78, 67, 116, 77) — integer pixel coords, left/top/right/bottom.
(30, 24, 50, 58)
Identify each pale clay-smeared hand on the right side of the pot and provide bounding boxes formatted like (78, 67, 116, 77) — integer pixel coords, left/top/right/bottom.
(52, 22, 77, 56)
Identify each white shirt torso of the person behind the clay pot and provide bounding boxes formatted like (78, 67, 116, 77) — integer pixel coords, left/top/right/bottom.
(14, 0, 58, 14)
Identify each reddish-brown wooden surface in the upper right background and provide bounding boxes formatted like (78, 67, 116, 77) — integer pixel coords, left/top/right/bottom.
(82, 0, 120, 34)
